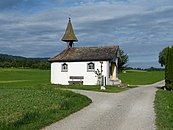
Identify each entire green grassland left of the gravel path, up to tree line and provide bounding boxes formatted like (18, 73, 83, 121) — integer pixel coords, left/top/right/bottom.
(0, 69, 91, 130)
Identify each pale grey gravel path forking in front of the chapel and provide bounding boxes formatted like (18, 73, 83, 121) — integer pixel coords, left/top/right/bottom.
(43, 81, 164, 130)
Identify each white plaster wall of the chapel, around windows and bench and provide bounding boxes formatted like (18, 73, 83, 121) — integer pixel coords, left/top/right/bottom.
(51, 61, 109, 85)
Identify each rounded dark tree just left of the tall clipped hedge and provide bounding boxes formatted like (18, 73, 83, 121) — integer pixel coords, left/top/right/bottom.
(159, 47, 168, 67)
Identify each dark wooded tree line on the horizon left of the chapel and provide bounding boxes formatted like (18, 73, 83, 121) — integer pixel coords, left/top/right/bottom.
(0, 54, 50, 69)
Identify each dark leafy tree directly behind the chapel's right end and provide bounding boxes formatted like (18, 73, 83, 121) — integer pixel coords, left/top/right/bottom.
(118, 49, 129, 72)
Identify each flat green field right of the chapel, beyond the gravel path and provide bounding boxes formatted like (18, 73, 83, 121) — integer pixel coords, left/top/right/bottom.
(119, 71, 164, 85)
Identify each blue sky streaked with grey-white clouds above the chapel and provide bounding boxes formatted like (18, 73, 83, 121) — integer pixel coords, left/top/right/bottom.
(0, 0, 173, 68)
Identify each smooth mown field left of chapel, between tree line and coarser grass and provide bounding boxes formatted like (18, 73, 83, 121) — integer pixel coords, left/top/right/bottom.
(0, 68, 50, 89)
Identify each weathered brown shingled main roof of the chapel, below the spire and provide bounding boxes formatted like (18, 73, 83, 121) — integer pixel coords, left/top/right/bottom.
(49, 46, 119, 62)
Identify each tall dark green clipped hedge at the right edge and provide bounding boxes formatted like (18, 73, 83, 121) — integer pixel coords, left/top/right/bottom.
(165, 47, 173, 90)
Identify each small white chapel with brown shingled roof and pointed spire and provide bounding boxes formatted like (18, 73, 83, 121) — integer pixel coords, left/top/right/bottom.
(49, 18, 119, 85)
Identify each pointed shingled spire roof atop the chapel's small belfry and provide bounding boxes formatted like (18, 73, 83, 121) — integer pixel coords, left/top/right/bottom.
(62, 18, 78, 42)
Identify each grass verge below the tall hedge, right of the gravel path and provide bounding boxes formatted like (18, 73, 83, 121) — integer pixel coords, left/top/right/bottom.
(155, 90, 173, 130)
